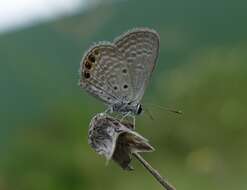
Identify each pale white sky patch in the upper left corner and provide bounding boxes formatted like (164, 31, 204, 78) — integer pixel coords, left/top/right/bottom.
(0, 0, 92, 33)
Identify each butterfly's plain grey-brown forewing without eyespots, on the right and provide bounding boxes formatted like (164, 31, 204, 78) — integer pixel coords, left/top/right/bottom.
(114, 28, 159, 102)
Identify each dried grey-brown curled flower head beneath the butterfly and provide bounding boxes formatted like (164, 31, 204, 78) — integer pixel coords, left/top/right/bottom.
(88, 113, 154, 170)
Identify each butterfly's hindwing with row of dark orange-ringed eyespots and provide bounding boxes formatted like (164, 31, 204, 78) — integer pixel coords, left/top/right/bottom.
(80, 42, 133, 105)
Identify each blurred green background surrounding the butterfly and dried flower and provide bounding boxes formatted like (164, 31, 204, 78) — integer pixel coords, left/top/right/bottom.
(0, 0, 247, 190)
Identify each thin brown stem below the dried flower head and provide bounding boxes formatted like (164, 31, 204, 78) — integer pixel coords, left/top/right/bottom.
(133, 153, 176, 190)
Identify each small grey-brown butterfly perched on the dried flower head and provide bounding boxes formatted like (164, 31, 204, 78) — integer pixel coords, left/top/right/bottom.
(79, 28, 160, 116)
